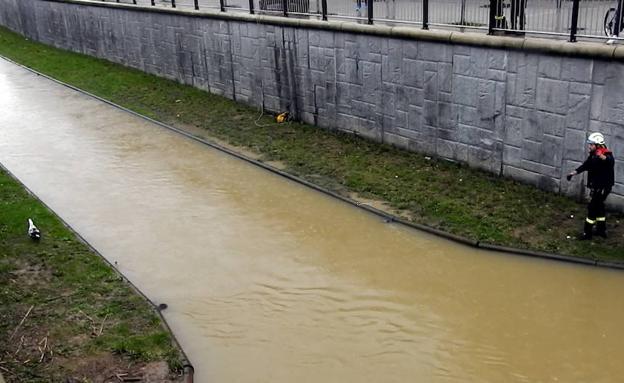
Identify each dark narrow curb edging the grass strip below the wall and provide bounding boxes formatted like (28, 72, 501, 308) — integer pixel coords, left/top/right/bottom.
(0, 54, 624, 272)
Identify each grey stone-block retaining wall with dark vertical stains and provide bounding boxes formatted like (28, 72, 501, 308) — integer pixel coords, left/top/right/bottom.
(0, 0, 624, 209)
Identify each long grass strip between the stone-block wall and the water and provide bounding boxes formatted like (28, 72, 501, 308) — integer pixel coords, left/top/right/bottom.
(0, 25, 624, 261)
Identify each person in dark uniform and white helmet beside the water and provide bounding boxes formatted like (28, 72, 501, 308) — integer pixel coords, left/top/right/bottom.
(566, 133, 615, 240)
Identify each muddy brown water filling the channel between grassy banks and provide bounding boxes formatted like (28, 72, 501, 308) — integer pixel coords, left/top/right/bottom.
(0, 59, 624, 383)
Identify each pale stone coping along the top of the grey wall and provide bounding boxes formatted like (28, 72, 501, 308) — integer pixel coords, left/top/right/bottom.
(43, 0, 624, 62)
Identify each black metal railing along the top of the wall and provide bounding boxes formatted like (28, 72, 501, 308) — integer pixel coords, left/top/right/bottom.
(97, 0, 624, 41)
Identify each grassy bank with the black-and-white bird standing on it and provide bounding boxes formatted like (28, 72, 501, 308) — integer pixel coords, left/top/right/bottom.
(0, 170, 181, 383)
